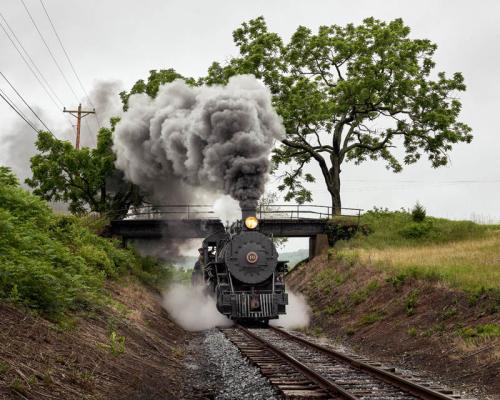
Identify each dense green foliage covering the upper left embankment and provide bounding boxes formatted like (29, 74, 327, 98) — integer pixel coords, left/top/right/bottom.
(0, 167, 168, 319)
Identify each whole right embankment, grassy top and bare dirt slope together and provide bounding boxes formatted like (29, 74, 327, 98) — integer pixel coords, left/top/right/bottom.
(287, 210, 500, 395)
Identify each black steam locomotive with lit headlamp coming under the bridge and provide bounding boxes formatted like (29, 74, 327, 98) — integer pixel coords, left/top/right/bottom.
(193, 210, 288, 323)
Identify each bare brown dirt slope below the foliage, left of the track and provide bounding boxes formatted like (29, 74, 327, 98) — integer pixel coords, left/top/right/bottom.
(0, 281, 198, 400)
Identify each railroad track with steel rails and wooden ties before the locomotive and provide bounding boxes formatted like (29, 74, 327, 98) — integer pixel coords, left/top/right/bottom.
(222, 325, 461, 400)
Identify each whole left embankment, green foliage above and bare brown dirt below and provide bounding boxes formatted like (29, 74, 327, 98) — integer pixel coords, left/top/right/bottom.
(0, 167, 195, 400)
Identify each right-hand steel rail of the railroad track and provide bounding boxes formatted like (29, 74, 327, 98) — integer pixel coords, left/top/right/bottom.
(269, 326, 456, 400)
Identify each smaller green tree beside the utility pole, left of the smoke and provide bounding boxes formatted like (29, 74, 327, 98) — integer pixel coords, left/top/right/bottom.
(26, 120, 142, 218)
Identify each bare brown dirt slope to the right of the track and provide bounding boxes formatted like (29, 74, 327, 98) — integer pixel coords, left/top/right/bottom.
(287, 255, 500, 398)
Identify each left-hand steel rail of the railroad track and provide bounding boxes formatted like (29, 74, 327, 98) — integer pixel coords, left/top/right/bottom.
(236, 325, 360, 400)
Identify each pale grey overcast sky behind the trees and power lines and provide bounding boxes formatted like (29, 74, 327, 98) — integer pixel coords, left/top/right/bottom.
(0, 0, 500, 252)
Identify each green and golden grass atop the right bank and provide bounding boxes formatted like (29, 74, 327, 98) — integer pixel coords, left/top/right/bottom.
(336, 211, 500, 291)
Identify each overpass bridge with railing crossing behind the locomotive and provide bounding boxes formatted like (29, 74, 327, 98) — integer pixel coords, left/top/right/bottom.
(111, 204, 361, 258)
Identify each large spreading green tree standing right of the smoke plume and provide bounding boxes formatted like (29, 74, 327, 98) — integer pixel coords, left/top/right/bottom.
(204, 17, 472, 213)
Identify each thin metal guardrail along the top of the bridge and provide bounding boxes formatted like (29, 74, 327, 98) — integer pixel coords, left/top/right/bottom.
(120, 204, 363, 222)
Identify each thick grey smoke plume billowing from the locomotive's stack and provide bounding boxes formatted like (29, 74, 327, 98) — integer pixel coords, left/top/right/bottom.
(114, 75, 284, 208)
